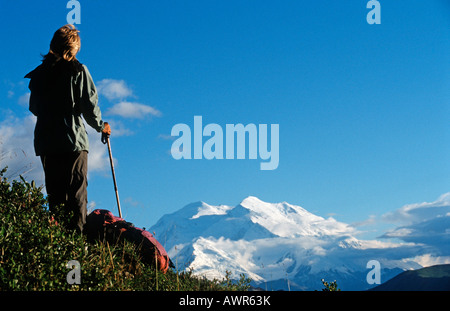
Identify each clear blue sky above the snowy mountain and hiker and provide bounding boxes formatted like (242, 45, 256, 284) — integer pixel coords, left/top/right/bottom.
(0, 0, 450, 240)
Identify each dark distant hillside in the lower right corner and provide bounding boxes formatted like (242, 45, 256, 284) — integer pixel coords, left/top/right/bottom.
(371, 265, 450, 291)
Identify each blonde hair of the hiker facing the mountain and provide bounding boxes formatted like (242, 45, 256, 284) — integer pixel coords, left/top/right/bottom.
(44, 24, 81, 61)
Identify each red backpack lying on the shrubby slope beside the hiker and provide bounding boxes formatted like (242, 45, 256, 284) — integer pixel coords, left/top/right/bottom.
(84, 209, 174, 273)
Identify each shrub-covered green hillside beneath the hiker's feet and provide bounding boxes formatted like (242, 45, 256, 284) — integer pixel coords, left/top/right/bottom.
(0, 169, 249, 291)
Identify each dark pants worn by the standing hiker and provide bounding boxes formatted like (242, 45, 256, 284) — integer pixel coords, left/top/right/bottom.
(41, 151, 88, 232)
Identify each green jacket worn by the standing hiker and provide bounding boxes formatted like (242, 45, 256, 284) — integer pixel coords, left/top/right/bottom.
(25, 55, 104, 156)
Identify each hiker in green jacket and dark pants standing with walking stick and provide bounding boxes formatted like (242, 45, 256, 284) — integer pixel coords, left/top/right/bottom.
(25, 25, 111, 232)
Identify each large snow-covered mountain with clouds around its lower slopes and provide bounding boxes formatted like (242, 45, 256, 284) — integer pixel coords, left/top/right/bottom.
(149, 196, 438, 290)
